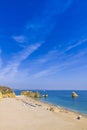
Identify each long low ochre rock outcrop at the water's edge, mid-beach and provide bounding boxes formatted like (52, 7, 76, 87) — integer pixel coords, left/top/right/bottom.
(21, 91, 41, 98)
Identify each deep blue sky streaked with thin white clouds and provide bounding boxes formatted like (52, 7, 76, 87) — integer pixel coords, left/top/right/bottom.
(0, 0, 87, 90)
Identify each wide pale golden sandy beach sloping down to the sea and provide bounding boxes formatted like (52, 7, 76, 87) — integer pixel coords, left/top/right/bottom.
(0, 96, 87, 130)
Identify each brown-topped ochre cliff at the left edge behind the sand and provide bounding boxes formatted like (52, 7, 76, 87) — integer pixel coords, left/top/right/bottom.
(0, 86, 15, 98)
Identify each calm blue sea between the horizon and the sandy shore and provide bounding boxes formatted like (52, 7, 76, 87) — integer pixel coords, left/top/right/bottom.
(14, 90, 87, 115)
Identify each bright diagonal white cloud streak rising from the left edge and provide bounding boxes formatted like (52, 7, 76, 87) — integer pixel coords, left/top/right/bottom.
(0, 43, 41, 79)
